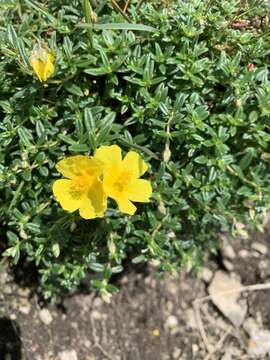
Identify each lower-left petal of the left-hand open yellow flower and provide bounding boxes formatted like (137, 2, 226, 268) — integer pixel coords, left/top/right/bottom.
(53, 179, 81, 212)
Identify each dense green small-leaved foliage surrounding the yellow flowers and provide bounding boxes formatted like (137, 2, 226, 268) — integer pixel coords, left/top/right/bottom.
(0, 0, 270, 297)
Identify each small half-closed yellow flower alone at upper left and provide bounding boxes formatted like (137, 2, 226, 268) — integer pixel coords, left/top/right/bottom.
(29, 47, 54, 81)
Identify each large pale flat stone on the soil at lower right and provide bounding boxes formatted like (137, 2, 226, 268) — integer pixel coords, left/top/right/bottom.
(208, 271, 247, 327)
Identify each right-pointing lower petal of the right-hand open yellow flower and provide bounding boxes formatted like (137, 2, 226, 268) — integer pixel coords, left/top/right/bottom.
(125, 179, 152, 202)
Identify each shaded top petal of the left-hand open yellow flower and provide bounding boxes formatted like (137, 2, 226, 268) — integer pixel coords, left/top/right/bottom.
(56, 155, 103, 179)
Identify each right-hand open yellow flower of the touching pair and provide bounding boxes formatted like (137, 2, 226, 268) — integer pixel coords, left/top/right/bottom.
(95, 145, 152, 215)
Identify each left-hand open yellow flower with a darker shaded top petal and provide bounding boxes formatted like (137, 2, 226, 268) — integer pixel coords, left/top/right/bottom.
(53, 155, 106, 219)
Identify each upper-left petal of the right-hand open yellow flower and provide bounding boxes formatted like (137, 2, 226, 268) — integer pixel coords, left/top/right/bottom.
(94, 145, 122, 176)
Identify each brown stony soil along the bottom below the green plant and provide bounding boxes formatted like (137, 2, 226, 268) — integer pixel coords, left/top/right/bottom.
(0, 225, 270, 360)
